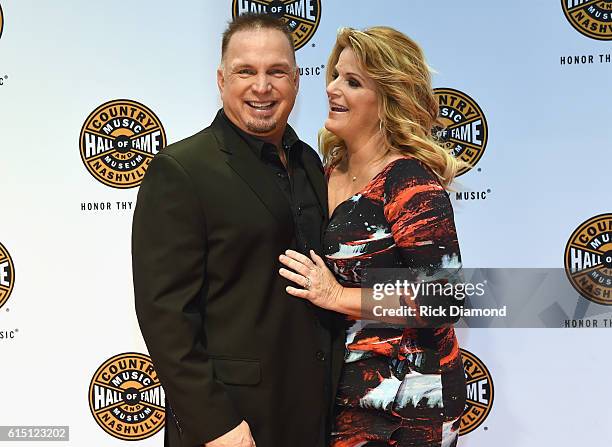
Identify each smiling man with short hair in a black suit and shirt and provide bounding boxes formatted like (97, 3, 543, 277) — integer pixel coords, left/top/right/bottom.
(132, 15, 343, 447)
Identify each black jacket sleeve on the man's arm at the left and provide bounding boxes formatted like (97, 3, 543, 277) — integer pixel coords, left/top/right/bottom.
(132, 154, 242, 446)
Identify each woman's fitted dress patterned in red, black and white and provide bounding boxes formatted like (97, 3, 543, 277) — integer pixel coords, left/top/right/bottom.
(324, 157, 466, 447)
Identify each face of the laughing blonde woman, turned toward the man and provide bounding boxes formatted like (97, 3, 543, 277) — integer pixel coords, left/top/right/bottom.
(325, 48, 379, 141)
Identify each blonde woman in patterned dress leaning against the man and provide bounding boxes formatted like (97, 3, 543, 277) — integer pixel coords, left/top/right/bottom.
(280, 27, 465, 447)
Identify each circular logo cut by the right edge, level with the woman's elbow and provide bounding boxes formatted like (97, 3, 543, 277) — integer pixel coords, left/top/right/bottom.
(565, 213, 612, 306)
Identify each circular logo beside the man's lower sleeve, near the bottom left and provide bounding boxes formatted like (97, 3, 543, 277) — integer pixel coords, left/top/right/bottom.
(89, 352, 166, 441)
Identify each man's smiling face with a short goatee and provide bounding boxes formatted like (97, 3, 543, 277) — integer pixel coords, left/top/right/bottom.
(217, 29, 299, 144)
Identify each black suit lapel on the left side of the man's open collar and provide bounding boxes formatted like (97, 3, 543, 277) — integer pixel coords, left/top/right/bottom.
(212, 114, 293, 231)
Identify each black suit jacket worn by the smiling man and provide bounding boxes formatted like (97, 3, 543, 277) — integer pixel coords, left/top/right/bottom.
(132, 114, 344, 447)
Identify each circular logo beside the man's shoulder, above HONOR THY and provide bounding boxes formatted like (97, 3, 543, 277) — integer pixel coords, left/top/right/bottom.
(80, 99, 166, 188)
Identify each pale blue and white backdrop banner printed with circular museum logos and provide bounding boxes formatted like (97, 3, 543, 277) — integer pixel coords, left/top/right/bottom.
(0, 0, 612, 447)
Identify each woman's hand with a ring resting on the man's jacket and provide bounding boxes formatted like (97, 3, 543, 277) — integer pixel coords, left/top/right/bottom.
(278, 250, 344, 310)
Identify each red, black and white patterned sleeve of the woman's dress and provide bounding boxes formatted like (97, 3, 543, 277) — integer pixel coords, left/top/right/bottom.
(384, 158, 463, 327)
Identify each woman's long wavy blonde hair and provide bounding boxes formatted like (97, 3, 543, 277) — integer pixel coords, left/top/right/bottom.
(319, 26, 462, 187)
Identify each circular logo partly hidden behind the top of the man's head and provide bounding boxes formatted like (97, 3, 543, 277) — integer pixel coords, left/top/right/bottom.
(232, 0, 321, 50)
